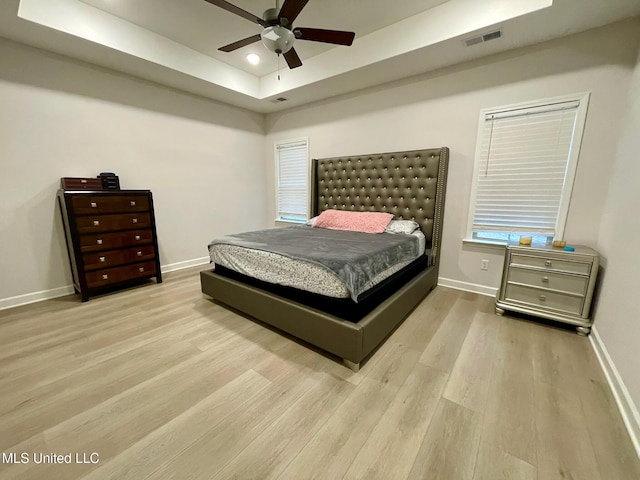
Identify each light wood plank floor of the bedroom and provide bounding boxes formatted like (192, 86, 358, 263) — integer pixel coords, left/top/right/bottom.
(0, 268, 640, 480)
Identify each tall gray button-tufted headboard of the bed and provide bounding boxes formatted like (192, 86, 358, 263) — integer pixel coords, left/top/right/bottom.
(311, 147, 449, 263)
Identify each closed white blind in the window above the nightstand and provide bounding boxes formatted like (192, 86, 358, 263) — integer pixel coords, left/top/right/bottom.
(472, 101, 580, 236)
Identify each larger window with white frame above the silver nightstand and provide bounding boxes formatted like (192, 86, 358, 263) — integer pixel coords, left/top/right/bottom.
(467, 93, 589, 243)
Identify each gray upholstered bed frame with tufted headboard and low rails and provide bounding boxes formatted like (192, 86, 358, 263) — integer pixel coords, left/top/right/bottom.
(200, 147, 449, 371)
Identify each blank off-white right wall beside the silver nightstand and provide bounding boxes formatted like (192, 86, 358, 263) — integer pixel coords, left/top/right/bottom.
(594, 46, 640, 454)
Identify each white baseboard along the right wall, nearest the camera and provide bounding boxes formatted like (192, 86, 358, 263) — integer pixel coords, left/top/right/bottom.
(589, 327, 640, 458)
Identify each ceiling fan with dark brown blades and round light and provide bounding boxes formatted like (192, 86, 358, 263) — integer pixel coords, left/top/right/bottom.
(205, 0, 356, 68)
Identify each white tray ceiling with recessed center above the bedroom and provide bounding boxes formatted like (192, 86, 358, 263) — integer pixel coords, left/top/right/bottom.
(0, 0, 640, 113)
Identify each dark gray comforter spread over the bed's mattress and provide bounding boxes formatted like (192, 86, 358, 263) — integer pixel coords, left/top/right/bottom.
(209, 226, 421, 302)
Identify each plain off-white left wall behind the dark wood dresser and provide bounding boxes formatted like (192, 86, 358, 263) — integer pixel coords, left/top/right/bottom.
(0, 39, 266, 307)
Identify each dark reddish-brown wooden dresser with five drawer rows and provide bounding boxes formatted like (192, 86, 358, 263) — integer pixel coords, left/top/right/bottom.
(58, 190, 162, 302)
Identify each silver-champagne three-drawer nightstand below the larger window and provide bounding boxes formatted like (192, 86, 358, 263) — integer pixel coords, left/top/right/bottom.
(496, 245, 599, 335)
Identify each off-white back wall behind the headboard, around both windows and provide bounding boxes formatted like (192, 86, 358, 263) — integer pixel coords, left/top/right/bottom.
(265, 18, 640, 292)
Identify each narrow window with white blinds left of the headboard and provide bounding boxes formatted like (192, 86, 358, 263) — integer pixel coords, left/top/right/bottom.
(275, 138, 309, 223)
